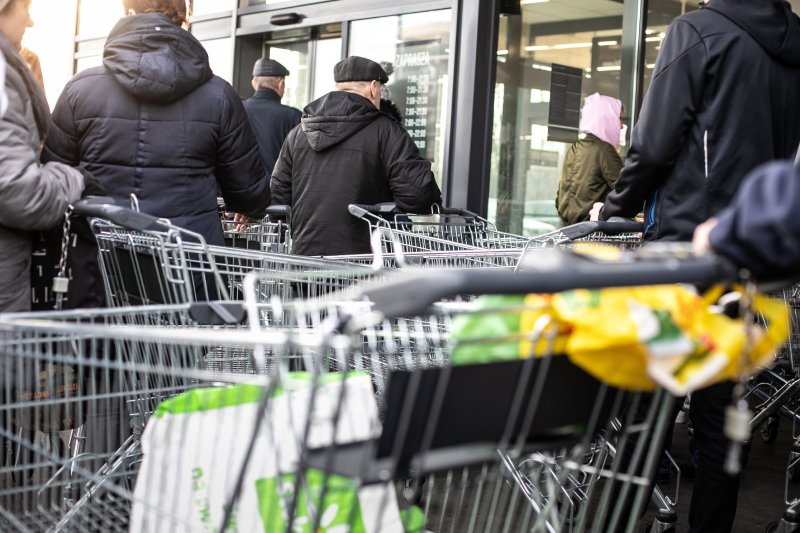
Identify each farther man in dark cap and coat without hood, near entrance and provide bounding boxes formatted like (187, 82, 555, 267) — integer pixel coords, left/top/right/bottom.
(244, 58, 302, 177)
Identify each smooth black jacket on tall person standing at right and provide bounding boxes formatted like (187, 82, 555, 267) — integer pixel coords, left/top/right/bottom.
(601, 0, 800, 240)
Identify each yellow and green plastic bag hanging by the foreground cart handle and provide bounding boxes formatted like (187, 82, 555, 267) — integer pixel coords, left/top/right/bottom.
(452, 285, 788, 395)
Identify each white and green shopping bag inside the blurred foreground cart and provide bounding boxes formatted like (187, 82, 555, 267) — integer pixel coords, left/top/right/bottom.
(130, 373, 422, 533)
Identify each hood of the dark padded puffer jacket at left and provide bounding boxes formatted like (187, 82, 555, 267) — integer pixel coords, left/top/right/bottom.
(103, 13, 213, 103)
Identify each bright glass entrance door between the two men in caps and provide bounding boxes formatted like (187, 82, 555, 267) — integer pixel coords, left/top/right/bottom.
(264, 24, 342, 109)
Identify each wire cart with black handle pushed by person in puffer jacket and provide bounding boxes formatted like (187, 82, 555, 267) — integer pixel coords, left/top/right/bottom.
(74, 199, 376, 307)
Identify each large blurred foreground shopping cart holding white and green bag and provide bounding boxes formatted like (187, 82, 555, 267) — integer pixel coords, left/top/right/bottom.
(0, 246, 756, 531)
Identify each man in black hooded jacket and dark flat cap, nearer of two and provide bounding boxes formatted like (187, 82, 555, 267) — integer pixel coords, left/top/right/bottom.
(270, 56, 441, 255)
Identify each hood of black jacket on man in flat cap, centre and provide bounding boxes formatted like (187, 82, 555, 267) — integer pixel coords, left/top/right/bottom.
(300, 91, 382, 152)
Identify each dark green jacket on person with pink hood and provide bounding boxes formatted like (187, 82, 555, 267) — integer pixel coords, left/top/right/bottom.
(556, 133, 622, 225)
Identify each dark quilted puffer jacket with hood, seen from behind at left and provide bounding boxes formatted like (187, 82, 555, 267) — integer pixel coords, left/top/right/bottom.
(43, 14, 270, 244)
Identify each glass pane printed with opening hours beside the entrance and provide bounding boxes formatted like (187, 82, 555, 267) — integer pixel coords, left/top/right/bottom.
(349, 9, 452, 187)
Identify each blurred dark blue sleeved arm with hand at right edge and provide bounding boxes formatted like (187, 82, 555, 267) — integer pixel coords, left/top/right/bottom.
(692, 163, 800, 279)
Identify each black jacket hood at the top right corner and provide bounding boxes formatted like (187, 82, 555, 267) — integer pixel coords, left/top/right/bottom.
(704, 0, 800, 65)
